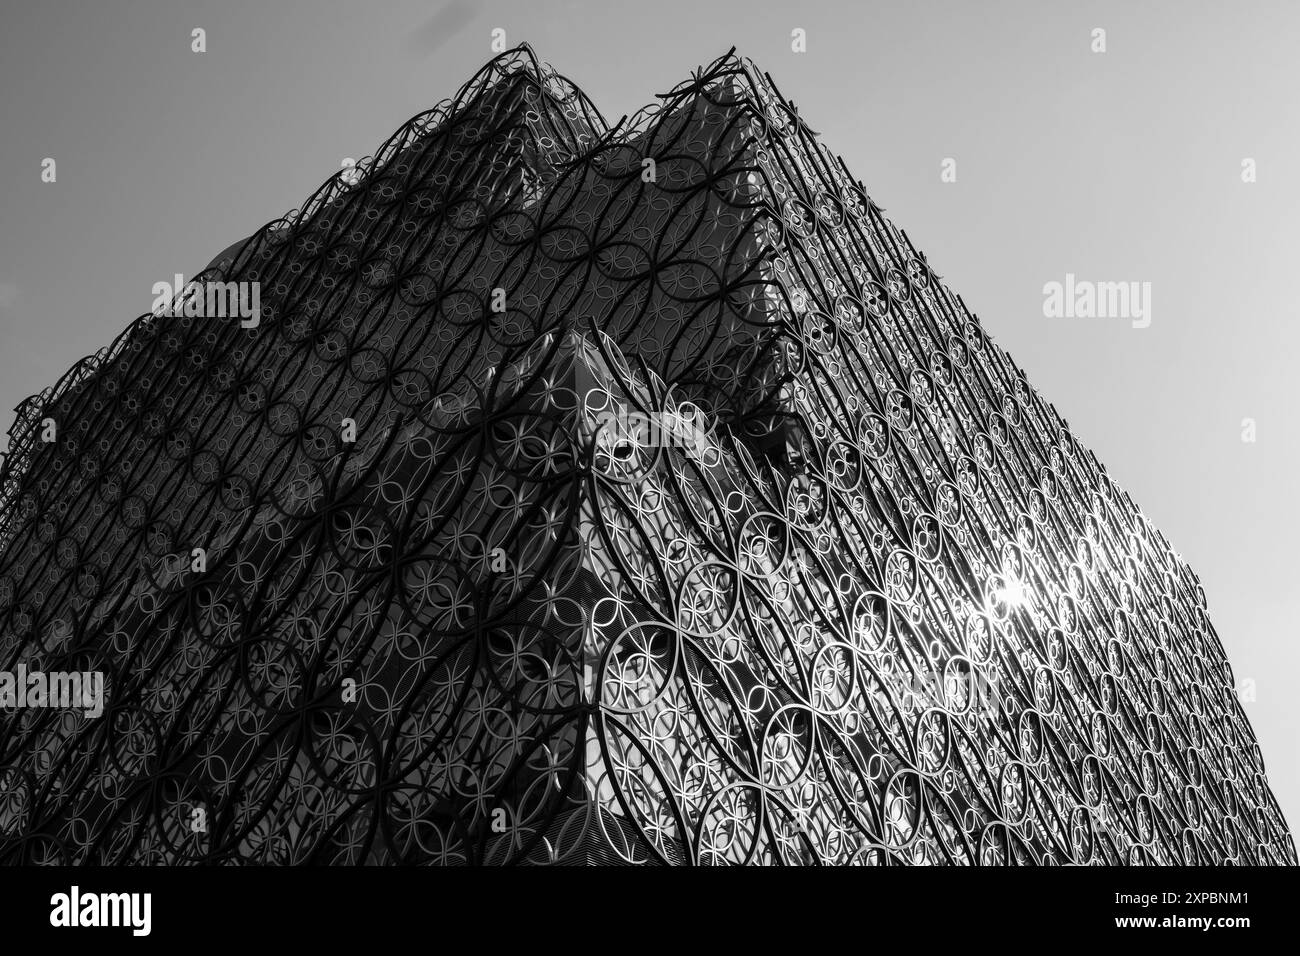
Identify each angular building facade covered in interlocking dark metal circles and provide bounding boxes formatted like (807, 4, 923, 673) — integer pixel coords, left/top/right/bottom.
(0, 48, 1296, 864)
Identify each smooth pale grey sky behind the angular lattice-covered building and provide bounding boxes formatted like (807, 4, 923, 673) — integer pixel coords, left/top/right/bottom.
(0, 0, 1300, 826)
